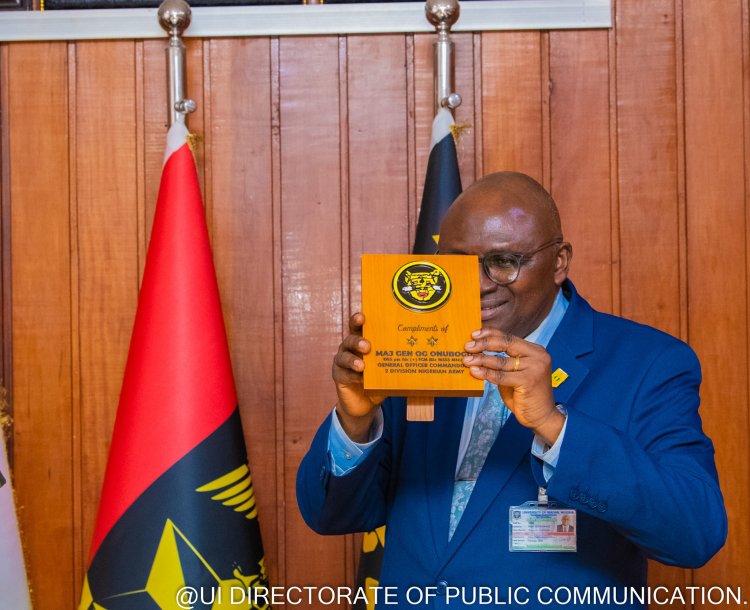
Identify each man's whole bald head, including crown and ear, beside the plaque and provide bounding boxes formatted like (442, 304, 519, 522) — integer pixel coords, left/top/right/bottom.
(439, 172, 572, 337)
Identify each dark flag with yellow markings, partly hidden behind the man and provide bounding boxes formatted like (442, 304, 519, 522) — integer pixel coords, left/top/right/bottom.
(354, 108, 462, 610)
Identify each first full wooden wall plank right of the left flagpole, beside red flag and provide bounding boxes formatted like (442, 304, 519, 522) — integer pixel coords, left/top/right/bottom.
(207, 38, 284, 583)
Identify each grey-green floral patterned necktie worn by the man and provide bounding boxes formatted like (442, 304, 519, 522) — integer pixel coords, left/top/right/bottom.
(448, 383, 510, 540)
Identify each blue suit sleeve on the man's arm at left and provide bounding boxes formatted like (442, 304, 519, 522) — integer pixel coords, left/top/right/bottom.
(297, 403, 392, 534)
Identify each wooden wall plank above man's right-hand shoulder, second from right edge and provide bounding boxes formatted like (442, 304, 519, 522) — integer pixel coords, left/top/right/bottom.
(613, 0, 692, 607)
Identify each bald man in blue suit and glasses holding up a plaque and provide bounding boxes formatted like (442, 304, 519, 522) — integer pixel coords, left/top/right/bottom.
(297, 173, 727, 608)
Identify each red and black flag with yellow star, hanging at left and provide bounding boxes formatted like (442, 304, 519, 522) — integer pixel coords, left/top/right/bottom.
(79, 123, 267, 610)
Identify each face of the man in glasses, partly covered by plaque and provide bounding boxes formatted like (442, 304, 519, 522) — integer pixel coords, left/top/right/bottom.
(440, 193, 569, 337)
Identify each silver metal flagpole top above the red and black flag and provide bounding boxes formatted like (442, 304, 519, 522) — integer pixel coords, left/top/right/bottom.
(158, 0, 196, 127)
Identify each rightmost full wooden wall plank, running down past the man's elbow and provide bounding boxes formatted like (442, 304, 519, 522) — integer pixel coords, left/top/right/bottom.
(683, 0, 750, 589)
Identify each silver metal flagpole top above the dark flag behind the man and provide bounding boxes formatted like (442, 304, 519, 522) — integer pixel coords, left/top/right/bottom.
(424, 0, 461, 114)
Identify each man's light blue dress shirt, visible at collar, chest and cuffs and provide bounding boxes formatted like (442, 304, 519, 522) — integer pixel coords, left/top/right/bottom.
(328, 290, 569, 481)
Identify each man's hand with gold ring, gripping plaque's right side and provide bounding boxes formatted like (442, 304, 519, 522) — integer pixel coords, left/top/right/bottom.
(464, 328, 565, 445)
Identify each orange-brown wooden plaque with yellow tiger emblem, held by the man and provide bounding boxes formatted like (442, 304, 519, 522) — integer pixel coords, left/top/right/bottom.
(362, 254, 484, 396)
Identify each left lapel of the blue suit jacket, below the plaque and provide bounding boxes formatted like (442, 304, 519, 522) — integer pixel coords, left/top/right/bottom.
(425, 398, 466, 556)
